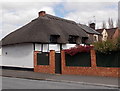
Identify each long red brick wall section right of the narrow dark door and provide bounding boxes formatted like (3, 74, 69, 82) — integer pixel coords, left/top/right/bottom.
(61, 50, 120, 77)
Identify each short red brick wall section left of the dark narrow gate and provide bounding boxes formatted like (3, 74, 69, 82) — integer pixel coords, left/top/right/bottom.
(34, 50, 55, 74)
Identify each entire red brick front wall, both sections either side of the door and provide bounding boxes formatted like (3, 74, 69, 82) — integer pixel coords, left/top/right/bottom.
(34, 50, 120, 77)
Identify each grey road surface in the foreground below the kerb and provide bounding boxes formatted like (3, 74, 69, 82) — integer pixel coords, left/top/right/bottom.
(2, 77, 114, 89)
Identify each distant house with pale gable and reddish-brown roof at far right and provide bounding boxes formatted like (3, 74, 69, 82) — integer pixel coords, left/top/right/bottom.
(96, 28, 119, 41)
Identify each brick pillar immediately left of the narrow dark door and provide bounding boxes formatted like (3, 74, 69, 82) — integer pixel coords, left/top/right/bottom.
(49, 50, 55, 74)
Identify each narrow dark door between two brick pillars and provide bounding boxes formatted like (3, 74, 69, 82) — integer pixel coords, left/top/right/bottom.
(55, 53, 61, 74)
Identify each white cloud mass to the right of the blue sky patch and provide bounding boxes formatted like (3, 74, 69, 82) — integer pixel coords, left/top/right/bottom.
(64, 2, 118, 28)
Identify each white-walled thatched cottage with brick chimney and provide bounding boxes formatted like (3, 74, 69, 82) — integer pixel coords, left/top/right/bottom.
(2, 11, 88, 68)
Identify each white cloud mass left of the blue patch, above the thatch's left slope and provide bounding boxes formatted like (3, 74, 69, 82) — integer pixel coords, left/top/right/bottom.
(0, 2, 57, 38)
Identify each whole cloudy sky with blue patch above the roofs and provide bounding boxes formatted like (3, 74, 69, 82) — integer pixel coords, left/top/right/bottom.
(0, 0, 118, 39)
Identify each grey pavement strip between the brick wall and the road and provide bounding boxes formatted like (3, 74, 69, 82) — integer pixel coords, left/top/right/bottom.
(0, 69, 120, 88)
